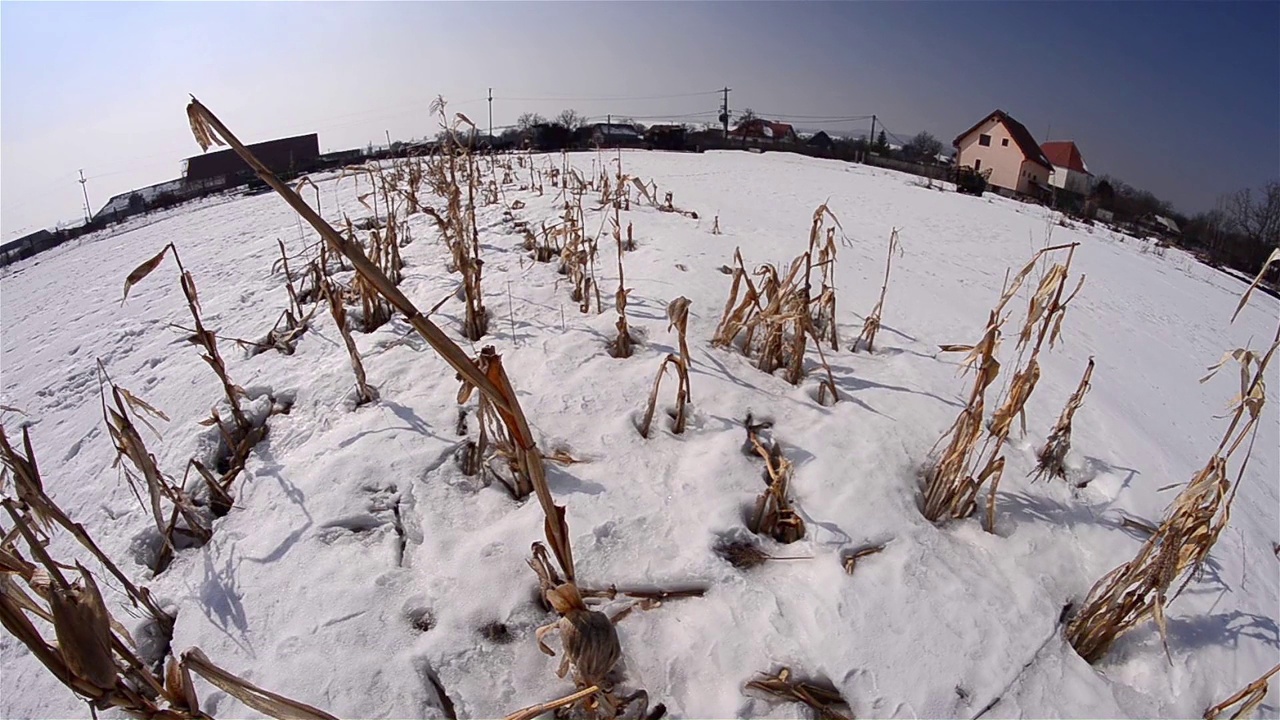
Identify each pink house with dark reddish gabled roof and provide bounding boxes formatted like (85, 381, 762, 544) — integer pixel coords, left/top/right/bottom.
(951, 110, 1053, 197)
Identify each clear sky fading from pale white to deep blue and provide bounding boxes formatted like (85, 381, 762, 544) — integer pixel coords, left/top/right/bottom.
(0, 1, 1280, 238)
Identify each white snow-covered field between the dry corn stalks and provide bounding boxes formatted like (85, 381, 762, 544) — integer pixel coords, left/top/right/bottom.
(0, 152, 1280, 717)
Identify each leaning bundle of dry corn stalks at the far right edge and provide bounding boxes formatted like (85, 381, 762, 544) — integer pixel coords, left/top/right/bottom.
(1066, 316, 1280, 662)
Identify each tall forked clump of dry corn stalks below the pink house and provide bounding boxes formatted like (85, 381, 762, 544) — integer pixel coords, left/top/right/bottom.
(923, 243, 1084, 532)
